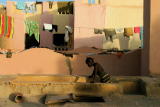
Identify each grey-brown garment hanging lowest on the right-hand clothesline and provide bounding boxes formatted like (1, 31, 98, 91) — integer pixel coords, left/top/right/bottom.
(103, 29, 116, 42)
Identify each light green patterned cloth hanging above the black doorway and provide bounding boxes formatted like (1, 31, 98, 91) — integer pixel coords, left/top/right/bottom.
(25, 20, 40, 42)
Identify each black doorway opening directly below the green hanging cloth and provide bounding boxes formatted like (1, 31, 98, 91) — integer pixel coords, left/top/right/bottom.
(25, 34, 39, 49)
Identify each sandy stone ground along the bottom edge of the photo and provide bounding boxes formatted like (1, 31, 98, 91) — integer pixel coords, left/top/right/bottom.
(0, 95, 160, 107)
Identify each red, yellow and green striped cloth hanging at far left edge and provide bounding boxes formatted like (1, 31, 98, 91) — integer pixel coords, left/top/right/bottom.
(0, 15, 14, 38)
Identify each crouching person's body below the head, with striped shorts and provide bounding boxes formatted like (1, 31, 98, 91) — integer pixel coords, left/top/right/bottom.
(91, 63, 110, 83)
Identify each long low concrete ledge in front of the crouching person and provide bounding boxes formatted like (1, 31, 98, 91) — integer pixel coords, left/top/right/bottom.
(0, 75, 160, 98)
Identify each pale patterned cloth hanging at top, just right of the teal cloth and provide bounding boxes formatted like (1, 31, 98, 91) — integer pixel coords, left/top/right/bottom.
(25, 2, 36, 13)
